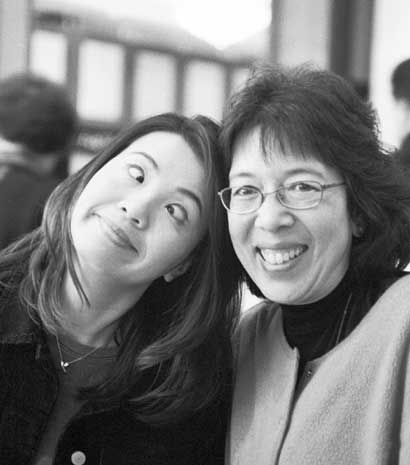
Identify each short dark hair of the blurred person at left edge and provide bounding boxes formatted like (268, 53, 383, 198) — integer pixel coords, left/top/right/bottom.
(0, 74, 77, 154)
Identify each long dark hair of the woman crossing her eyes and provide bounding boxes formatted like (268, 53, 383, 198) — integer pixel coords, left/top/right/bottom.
(0, 113, 239, 423)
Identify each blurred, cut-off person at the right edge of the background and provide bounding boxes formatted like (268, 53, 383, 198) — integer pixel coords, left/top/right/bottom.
(391, 59, 410, 170)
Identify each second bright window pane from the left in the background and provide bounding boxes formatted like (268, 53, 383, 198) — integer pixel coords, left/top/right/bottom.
(77, 40, 124, 121)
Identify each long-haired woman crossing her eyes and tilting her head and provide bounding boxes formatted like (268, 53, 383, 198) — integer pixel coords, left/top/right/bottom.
(0, 114, 242, 465)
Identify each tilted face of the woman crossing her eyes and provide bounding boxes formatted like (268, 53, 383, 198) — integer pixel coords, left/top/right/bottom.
(71, 132, 208, 287)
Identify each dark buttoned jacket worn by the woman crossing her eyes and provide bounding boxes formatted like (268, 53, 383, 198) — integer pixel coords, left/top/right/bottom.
(0, 278, 230, 465)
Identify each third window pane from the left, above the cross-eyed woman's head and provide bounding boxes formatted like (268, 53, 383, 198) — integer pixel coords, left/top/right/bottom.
(133, 52, 176, 119)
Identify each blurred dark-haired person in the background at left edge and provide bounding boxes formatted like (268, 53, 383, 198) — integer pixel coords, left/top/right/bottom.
(0, 74, 77, 249)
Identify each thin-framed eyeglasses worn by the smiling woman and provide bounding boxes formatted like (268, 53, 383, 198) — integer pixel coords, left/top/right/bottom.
(218, 181, 345, 215)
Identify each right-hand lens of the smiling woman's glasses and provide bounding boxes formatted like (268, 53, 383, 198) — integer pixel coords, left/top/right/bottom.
(279, 181, 322, 209)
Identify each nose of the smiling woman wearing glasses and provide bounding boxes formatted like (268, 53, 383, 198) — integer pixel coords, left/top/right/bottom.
(255, 193, 296, 231)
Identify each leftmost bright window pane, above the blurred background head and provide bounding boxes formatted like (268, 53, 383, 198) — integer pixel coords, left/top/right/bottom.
(30, 30, 67, 84)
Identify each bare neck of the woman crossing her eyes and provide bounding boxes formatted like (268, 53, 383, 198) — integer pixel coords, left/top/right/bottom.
(63, 266, 150, 347)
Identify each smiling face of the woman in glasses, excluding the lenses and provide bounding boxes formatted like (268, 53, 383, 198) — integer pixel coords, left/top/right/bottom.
(228, 129, 355, 304)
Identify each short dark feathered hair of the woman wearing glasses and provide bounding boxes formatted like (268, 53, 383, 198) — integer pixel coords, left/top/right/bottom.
(221, 65, 410, 295)
